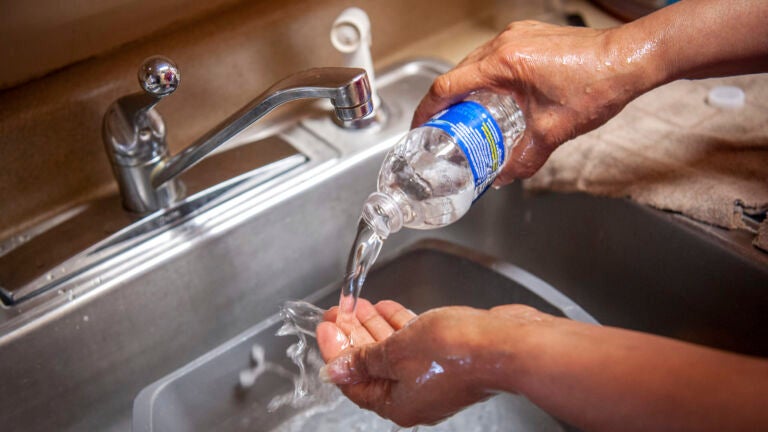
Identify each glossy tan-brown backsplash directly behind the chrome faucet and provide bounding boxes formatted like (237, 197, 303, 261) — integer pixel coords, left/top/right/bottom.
(0, 0, 492, 238)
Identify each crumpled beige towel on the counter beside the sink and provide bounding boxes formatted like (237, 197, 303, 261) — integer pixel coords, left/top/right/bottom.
(525, 74, 768, 252)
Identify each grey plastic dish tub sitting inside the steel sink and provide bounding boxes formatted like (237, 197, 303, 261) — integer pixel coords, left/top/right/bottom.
(133, 241, 595, 432)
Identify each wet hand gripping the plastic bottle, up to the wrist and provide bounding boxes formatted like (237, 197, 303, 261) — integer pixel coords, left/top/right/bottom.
(412, 21, 655, 185)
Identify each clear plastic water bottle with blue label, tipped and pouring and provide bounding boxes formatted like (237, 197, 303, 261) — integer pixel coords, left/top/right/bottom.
(362, 92, 525, 239)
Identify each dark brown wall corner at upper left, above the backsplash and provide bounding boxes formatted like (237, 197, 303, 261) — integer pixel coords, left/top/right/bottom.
(0, 0, 243, 89)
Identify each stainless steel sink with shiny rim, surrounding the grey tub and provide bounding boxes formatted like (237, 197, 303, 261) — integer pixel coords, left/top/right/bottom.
(0, 61, 768, 431)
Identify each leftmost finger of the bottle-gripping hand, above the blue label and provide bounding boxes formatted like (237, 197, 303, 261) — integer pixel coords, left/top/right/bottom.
(411, 63, 488, 128)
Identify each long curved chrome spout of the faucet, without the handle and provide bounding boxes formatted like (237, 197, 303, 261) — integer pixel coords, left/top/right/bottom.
(151, 67, 373, 188)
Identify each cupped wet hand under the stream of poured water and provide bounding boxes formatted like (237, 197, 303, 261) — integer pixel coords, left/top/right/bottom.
(317, 300, 548, 426)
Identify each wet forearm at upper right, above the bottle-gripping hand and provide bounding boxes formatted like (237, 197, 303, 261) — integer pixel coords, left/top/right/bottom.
(610, 0, 768, 90)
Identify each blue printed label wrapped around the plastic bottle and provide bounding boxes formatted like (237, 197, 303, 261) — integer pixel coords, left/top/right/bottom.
(424, 101, 506, 199)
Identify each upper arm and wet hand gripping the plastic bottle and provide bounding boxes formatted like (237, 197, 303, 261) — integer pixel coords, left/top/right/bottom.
(413, 0, 768, 184)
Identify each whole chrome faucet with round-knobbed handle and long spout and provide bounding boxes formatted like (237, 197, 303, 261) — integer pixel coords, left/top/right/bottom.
(102, 56, 373, 214)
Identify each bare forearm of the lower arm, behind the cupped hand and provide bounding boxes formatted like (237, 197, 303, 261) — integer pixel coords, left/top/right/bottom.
(496, 319, 768, 432)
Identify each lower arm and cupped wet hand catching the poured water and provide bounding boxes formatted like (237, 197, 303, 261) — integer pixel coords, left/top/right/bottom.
(317, 300, 768, 432)
